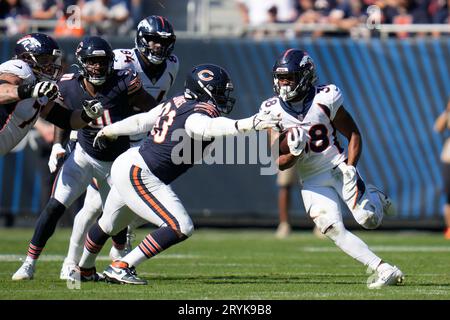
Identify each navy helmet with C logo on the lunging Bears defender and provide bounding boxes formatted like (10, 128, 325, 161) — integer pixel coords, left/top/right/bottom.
(184, 64, 236, 114)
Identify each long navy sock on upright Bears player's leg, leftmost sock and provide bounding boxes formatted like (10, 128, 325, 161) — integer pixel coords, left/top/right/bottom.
(27, 198, 66, 263)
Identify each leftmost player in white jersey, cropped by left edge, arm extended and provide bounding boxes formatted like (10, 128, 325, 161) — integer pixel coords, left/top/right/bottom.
(0, 33, 103, 155)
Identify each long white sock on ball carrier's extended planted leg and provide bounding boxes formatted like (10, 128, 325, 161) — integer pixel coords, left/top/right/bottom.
(325, 222, 381, 270)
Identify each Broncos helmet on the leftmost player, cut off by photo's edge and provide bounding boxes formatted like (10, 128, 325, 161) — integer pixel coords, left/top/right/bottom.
(13, 33, 62, 81)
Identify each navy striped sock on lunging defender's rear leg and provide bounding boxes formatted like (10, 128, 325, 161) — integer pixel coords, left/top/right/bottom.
(79, 222, 110, 269)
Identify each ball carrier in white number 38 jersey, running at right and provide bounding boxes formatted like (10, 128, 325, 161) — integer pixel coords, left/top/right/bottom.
(261, 49, 403, 288)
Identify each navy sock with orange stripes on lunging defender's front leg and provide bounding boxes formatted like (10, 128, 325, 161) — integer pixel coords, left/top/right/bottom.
(122, 227, 187, 267)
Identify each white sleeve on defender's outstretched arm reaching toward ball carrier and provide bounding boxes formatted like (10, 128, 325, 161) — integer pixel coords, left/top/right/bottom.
(185, 113, 239, 140)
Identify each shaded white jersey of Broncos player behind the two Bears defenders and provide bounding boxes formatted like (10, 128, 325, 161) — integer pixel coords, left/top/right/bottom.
(114, 48, 180, 144)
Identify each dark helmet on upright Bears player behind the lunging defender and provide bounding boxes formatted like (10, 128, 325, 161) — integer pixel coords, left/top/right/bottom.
(75, 36, 114, 86)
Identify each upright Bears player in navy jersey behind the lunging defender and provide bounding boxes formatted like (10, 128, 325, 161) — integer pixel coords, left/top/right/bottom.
(12, 37, 156, 280)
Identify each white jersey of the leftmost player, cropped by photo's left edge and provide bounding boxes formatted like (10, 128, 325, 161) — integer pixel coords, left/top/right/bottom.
(0, 60, 47, 155)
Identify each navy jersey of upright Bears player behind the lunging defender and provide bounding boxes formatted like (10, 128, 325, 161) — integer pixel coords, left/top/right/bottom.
(58, 69, 142, 161)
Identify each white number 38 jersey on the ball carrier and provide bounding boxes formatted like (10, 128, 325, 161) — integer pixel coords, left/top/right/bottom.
(261, 84, 347, 180)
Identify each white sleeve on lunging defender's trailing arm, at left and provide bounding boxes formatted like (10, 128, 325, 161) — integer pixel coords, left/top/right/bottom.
(103, 104, 164, 136)
